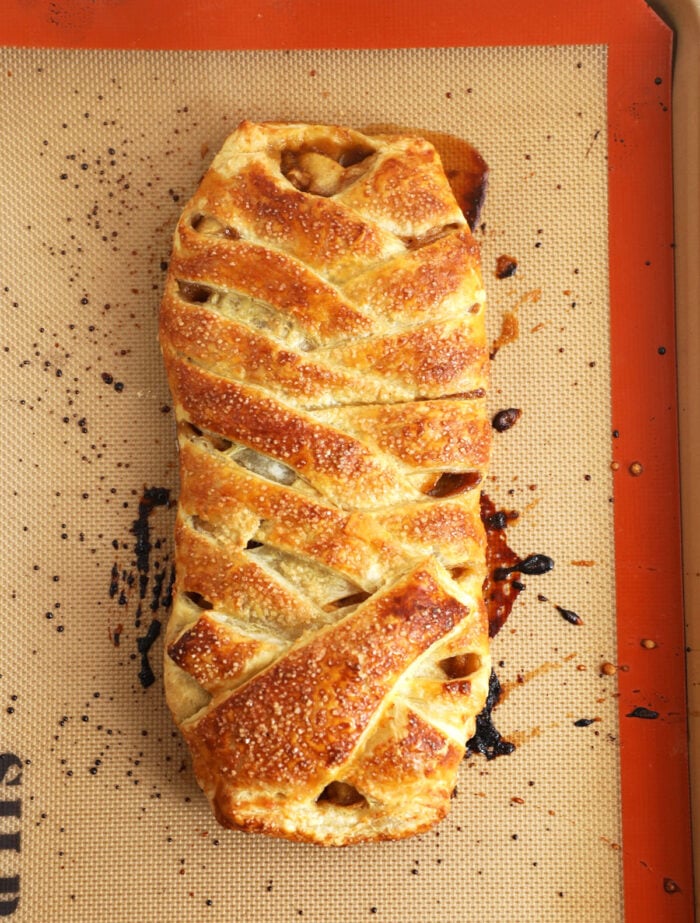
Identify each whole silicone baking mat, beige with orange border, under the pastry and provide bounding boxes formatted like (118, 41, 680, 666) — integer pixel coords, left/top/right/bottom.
(0, 0, 692, 923)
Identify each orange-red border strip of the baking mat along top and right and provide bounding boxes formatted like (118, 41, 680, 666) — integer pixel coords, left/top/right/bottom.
(0, 0, 694, 923)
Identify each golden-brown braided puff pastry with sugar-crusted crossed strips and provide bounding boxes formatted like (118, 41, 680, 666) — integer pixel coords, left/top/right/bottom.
(160, 122, 490, 845)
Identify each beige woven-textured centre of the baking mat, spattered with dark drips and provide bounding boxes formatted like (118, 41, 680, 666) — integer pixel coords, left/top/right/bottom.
(0, 46, 624, 923)
